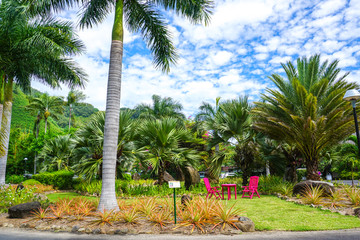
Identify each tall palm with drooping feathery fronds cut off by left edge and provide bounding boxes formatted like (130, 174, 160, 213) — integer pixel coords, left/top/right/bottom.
(0, 0, 85, 185)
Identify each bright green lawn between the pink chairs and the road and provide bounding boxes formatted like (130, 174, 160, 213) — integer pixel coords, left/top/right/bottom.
(230, 195, 360, 231)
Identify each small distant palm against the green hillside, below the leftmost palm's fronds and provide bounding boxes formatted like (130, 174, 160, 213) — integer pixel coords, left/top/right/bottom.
(26, 93, 64, 134)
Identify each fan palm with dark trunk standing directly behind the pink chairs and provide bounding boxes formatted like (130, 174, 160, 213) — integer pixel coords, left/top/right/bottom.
(196, 97, 258, 184)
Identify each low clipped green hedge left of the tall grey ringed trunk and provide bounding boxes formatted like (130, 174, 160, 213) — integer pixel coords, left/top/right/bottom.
(33, 170, 74, 189)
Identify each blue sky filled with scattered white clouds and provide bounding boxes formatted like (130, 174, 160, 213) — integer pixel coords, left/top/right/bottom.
(33, 0, 360, 116)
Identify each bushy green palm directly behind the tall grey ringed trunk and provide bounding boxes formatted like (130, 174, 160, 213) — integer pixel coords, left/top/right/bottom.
(74, 110, 138, 181)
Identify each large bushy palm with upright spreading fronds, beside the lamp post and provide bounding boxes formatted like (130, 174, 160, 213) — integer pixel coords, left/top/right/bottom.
(253, 55, 357, 180)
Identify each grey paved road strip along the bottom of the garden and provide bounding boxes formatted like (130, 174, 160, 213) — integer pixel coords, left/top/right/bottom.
(0, 228, 360, 240)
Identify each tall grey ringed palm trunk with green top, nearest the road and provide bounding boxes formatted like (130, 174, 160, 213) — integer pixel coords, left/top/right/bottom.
(98, 0, 123, 211)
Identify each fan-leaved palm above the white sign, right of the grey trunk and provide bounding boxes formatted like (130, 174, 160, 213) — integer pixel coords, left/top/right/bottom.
(138, 117, 200, 185)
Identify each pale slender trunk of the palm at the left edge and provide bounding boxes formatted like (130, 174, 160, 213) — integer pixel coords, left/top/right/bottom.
(0, 79, 13, 185)
